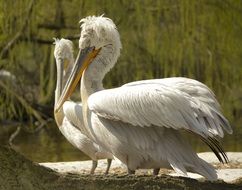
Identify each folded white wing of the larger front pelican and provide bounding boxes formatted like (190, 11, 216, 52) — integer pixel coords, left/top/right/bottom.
(88, 78, 232, 137)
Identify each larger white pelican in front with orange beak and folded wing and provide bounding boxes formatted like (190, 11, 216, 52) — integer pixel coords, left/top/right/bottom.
(55, 16, 232, 180)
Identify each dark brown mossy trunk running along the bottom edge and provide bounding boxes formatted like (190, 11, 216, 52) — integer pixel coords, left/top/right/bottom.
(0, 145, 242, 190)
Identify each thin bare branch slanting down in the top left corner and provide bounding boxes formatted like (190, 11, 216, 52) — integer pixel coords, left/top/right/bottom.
(0, 0, 35, 59)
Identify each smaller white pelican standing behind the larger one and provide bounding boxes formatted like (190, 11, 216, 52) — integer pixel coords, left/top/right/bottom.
(54, 39, 113, 174)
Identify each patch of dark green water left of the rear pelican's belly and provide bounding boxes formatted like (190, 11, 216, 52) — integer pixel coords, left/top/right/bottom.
(9, 124, 90, 162)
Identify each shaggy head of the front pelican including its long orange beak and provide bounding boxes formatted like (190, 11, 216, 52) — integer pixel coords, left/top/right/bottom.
(55, 16, 122, 112)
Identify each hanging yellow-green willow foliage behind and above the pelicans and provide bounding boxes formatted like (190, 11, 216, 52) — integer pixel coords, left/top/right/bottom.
(0, 0, 242, 124)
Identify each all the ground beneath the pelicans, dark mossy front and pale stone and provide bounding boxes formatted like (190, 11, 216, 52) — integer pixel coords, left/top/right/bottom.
(0, 145, 242, 190)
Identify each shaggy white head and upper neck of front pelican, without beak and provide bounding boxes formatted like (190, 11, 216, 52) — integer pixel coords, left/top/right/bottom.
(79, 16, 122, 80)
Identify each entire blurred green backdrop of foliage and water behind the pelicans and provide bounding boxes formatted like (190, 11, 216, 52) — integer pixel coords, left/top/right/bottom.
(0, 0, 242, 161)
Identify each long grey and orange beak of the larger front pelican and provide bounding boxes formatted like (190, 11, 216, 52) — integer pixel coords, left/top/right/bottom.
(55, 47, 101, 113)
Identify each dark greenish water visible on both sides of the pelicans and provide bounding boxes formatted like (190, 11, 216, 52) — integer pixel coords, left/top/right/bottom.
(0, 121, 242, 162)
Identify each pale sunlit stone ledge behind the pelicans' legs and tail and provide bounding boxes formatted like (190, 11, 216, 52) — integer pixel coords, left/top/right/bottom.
(40, 152, 242, 183)
